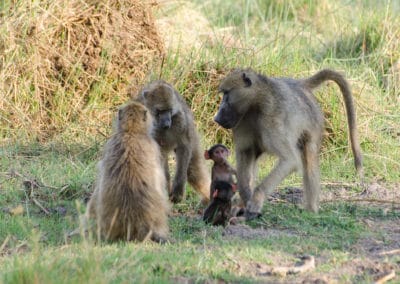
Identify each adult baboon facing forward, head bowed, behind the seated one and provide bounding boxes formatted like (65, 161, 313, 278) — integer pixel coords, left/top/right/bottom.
(137, 81, 210, 202)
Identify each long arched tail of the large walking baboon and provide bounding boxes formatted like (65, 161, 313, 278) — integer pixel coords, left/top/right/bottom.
(304, 69, 363, 177)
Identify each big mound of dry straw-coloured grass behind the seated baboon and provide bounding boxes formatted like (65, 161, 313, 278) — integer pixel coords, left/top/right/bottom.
(0, 0, 163, 141)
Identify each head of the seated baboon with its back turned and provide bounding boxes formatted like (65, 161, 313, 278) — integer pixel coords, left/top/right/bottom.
(117, 101, 153, 133)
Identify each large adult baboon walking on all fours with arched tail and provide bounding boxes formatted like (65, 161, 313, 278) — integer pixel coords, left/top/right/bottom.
(215, 69, 362, 216)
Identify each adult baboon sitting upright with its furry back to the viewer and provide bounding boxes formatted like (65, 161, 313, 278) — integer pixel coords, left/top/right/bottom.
(87, 102, 169, 242)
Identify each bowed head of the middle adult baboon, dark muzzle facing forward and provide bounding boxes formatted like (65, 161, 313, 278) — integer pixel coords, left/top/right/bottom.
(141, 81, 179, 130)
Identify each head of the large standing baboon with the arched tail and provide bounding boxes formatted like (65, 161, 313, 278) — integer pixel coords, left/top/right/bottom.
(214, 69, 258, 129)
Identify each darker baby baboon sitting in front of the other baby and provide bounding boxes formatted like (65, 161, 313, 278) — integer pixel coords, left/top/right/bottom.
(203, 180, 236, 226)
